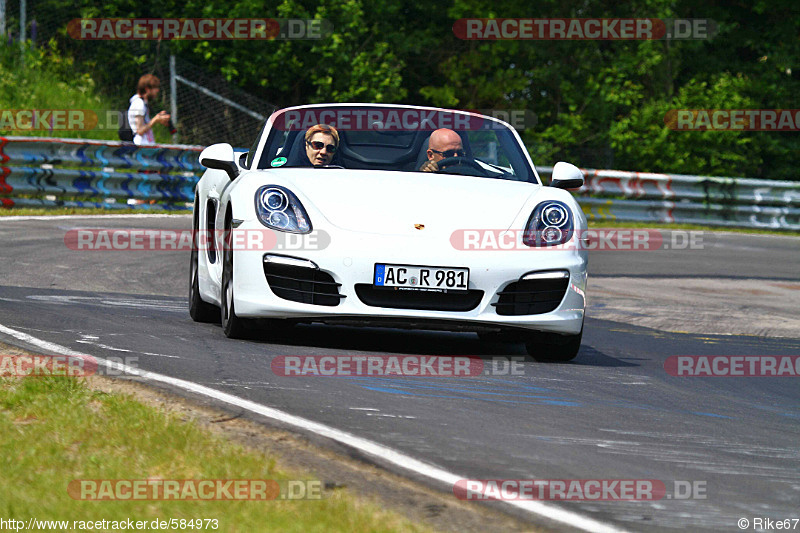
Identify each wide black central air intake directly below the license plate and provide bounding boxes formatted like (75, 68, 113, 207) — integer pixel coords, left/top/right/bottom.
(356, 283, 483, 311)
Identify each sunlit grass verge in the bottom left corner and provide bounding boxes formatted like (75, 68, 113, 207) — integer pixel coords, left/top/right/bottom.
(0, 370, 427, 532)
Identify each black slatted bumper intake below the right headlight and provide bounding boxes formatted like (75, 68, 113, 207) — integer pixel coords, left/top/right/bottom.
(492, 278, 569, 316)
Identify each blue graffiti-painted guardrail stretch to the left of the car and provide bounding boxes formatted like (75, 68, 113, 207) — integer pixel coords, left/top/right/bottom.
(0, 137, 204, 209)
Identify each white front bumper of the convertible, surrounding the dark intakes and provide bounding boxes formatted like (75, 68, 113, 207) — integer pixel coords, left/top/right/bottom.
(233, 222, 587, 335)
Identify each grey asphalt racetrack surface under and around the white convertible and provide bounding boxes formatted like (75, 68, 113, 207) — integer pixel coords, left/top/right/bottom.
(0, 216, 800, 531)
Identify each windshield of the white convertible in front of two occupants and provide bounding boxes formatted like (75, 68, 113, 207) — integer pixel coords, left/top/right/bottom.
(257, 106, 538, 183)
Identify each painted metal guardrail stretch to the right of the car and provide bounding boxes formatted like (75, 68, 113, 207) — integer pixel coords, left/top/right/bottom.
(537, 167, 800, 230)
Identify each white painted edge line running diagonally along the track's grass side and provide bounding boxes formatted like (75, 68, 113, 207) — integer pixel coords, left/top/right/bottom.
(0, 324, 625, 533)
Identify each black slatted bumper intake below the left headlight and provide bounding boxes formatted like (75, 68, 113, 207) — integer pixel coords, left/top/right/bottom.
(264, 263, 344, 306)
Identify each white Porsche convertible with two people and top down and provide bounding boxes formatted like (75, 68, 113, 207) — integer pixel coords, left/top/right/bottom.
(190, 104, 587, 361)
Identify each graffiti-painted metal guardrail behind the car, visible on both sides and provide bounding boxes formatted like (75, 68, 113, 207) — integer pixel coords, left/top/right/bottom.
(0, 137, 800, 230)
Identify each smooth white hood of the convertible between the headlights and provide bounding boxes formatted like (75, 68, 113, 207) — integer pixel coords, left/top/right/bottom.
(253, 169, 541, 234)
